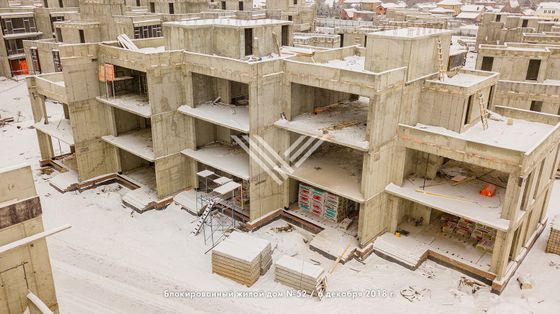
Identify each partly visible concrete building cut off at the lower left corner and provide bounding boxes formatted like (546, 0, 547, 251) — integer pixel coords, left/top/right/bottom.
(0, 165, 67, 314)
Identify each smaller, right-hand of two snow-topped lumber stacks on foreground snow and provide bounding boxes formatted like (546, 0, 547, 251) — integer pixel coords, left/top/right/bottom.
(275, 255, 327, 296)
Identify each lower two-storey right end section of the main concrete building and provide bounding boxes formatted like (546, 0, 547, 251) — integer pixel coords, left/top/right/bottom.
(362, 32, 560, 291)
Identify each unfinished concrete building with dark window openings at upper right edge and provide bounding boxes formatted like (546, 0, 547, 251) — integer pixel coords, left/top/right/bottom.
(476, 14, 560, 115)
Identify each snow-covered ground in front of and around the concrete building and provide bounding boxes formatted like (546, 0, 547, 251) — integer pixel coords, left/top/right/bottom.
(0, 78, 560, 314)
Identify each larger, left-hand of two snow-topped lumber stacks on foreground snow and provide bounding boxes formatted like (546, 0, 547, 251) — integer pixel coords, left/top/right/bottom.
(212, 231, 272, 287)
